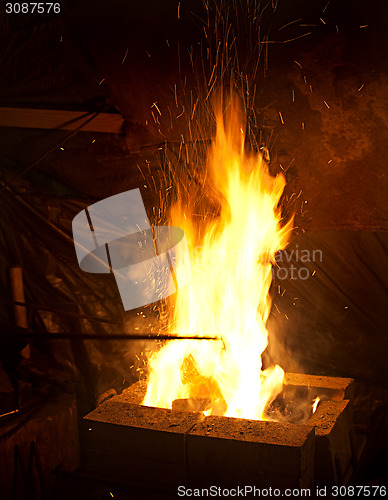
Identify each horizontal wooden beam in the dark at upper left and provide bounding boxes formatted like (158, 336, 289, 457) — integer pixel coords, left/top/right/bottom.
(0, 107, 124, 134)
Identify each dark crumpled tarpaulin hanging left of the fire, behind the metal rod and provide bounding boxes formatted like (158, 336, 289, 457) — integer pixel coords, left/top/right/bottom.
(0, 164, 161, 406)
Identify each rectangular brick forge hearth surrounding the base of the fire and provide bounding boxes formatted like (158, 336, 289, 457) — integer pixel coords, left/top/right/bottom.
(82, 374, 356, 491)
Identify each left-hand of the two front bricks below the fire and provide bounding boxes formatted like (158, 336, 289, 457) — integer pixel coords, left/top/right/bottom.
(82, 402, 203, 488)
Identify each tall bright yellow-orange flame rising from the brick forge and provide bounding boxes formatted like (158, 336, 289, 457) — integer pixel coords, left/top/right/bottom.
(143, 95, 292, 419)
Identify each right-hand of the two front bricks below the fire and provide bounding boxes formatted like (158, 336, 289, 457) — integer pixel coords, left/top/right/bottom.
(187, 416, 315, 487)
